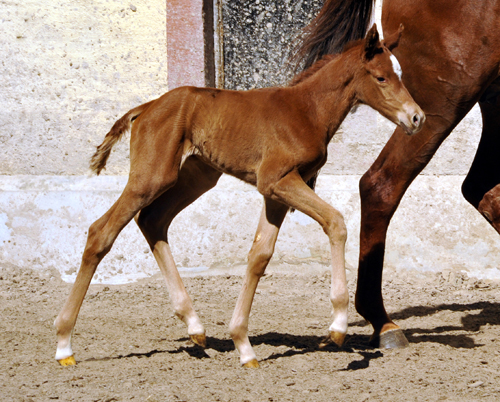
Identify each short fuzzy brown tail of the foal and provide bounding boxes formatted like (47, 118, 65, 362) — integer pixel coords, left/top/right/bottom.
(90, 101, 153, 175)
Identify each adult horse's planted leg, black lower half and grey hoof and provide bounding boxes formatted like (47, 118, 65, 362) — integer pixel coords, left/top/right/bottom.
(356, 109, 482, 348)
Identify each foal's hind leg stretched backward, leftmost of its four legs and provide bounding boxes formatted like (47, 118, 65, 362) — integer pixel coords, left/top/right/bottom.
(54, 125, 186, 365)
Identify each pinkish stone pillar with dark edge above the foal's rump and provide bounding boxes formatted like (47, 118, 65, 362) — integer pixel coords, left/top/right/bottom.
(167, 0, 215, 90)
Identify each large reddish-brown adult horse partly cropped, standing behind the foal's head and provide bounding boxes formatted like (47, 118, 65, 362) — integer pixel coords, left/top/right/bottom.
(298, 0, 500, 348)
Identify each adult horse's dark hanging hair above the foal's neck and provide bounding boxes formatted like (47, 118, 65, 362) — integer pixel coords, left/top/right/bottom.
(291, 0, 375, 70)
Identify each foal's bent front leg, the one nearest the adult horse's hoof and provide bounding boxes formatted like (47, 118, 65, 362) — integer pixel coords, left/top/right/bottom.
(264, 171, 349, 346)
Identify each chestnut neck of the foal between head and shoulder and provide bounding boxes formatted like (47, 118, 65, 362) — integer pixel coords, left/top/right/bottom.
(296, 49, 361, 141)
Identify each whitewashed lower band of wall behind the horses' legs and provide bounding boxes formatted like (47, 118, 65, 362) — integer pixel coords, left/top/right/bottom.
(0, 175, 500, 284)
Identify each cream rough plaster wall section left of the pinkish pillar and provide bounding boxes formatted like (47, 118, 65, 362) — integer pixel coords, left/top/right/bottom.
(0, 0, 167, 175)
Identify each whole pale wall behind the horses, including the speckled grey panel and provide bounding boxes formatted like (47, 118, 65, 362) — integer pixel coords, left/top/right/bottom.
(0, 0, 500, 283)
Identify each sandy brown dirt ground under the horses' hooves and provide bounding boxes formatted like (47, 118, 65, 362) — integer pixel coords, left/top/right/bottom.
(0, 266, 500, 402)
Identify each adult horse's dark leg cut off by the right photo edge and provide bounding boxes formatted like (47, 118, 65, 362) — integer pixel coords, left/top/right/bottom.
(462, 80, 500, 229)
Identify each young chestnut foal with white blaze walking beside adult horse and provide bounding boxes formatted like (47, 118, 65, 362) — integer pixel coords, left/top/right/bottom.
(55, 26, 425, 367)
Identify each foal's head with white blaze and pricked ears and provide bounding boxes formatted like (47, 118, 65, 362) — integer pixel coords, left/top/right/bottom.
(356, 24, 425, 135)
